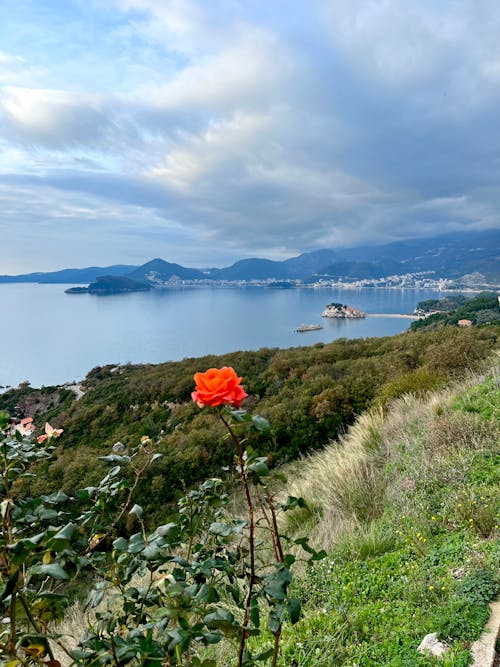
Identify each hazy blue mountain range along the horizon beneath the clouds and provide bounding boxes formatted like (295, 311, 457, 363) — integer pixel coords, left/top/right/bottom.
(0, 230, 500, 285)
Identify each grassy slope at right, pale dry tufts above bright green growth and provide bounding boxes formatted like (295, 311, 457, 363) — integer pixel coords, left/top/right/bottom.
(268, 364, 500, 667)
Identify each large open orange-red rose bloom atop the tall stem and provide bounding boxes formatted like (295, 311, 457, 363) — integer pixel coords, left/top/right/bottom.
(191, 366, 248, 408)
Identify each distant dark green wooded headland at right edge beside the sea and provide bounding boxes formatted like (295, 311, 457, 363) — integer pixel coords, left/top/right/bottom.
(411, 292, 500, 331)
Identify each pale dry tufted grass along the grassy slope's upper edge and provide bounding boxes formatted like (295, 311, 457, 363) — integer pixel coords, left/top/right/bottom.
(283, 359, 500, 550)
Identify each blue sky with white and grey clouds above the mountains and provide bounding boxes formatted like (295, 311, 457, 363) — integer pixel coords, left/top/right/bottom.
(0, 0, 500, 274)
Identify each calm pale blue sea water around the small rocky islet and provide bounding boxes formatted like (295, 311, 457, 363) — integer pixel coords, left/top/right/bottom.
(0, 284, 439, 386)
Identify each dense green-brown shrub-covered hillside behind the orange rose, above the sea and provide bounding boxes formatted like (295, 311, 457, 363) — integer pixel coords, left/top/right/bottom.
(0, 326, 500, 520)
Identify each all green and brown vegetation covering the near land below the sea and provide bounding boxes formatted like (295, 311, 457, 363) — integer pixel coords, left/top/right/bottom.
(0, 327, 500, 667)
